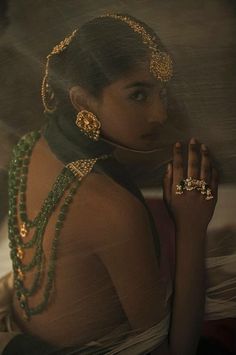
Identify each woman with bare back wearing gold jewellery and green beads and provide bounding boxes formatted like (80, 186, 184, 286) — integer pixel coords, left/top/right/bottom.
(2, 15, 217, 355)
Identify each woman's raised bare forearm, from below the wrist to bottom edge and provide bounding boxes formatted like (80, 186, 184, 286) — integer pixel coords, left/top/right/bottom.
(169, 226, 206, 355)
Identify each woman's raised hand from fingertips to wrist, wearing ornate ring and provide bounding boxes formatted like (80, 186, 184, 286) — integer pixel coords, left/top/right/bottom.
(164, 138, 218, 231)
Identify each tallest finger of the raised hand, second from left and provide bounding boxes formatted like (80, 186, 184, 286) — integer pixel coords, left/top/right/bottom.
(187, 138, 200, 179)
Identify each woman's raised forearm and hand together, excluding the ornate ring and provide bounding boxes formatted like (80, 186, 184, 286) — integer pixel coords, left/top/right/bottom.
(155, 140, 217, 355)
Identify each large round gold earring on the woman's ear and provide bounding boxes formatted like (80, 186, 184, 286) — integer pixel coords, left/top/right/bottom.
(76, 110, 101, 141)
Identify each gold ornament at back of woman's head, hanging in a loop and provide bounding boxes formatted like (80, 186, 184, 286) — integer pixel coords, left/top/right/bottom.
(41, 29, 78, 112)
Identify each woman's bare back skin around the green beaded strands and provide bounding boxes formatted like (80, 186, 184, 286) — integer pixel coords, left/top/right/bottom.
(11, 138, 128, 346)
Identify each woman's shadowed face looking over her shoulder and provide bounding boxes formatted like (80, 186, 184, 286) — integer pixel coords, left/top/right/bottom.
(93, 65, 167, 150)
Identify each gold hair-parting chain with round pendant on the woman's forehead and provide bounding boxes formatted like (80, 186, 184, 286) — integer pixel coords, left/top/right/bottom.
(101, 14, 173, 82)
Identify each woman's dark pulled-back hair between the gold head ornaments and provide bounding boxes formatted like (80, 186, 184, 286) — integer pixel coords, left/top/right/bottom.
(48, 14, 166, 117)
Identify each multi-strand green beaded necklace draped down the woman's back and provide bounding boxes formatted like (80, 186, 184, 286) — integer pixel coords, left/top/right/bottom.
(8, 132, 111, 320)
